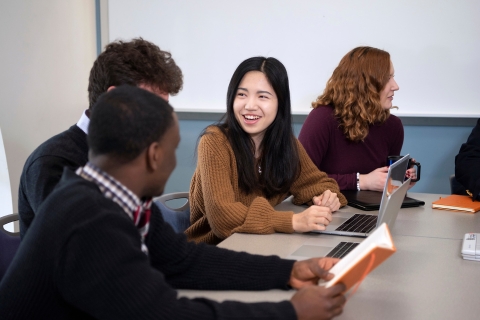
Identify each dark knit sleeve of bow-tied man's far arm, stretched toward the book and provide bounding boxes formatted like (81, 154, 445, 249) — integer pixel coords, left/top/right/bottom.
(147, 206, 294, 290)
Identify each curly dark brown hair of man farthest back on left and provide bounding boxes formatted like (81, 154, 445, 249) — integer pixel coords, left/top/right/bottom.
(88, 38, 183, 109)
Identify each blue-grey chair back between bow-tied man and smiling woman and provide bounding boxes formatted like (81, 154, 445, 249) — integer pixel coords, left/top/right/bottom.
(153, 192, 190, 233)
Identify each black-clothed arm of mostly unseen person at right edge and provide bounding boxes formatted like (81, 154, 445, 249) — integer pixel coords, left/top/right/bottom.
(455, 119, 480, 200)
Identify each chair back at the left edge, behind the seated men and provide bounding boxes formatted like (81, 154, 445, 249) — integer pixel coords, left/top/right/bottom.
(0, 213, 20, 280)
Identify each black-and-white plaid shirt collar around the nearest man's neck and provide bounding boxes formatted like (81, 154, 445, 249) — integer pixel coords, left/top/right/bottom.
(76, 162, 142, 220)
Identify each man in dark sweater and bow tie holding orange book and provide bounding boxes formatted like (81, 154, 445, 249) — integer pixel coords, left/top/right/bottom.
(0, 86, 345, 319)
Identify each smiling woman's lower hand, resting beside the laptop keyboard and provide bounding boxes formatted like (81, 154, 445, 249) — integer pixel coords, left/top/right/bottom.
(292, 205, 332, 232)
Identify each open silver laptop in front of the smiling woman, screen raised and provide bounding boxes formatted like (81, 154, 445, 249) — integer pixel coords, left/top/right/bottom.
(314, 155, 410, 238)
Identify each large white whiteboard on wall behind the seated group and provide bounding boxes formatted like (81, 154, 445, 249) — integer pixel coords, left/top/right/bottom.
(108, 0, 480, 117)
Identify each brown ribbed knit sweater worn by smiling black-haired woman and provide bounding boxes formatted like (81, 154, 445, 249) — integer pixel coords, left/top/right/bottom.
(185, 127, 347, 244)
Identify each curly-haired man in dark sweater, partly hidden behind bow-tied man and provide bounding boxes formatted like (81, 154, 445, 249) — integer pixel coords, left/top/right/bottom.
(18, 38, 183, 239)
